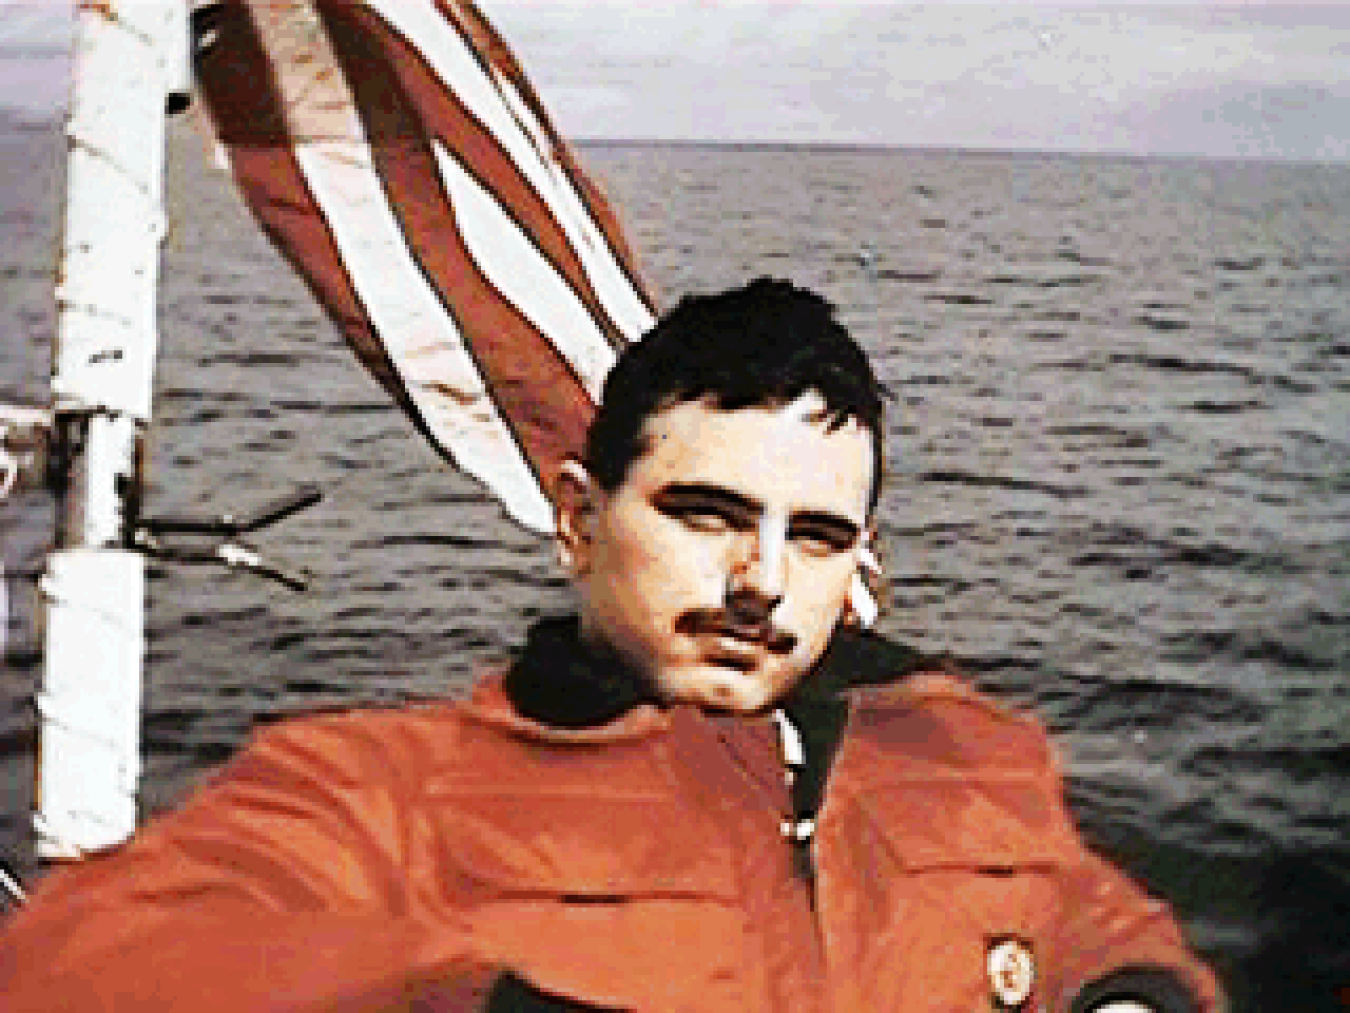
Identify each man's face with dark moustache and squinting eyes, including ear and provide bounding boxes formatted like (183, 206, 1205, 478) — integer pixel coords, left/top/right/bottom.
(558, 393, 872, 713)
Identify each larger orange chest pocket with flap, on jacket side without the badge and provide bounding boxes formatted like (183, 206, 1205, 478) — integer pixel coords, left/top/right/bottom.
(423, 786, 745, 1012)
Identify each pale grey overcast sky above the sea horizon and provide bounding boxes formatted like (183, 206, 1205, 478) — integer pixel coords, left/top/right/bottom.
(0, 0, 1350, 159)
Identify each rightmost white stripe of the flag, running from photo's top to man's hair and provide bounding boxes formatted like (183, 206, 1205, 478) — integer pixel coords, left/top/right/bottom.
(370, 0, 653, 340)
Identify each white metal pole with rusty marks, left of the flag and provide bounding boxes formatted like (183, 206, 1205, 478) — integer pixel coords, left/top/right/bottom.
(34, 0, 188, 859)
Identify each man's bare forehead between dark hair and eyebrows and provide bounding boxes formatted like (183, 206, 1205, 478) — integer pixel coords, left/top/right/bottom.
(625, 392, 872, 525)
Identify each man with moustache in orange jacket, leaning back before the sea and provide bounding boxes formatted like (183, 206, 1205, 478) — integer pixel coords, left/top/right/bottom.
(0, 281, 1218, 1013)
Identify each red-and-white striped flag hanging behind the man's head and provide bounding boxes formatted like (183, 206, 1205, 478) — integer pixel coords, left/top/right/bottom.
(196, 0, 653, 531)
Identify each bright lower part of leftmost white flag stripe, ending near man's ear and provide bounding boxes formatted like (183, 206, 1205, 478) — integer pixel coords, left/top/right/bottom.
(296, 142, 554, 534)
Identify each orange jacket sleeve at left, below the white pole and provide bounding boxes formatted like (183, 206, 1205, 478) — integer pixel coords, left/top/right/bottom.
(0, 719, 497, 1013)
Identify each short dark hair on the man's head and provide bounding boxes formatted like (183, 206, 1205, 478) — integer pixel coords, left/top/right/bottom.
(585, 278, 888, 509)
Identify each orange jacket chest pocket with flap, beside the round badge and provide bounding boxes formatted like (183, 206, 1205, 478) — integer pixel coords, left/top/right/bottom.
(849, 774, 1068, 1010)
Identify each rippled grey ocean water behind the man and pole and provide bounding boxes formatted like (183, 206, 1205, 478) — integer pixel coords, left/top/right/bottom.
(0, 114, 1350, 1010)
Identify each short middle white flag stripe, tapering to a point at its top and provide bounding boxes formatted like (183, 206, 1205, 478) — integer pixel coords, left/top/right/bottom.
(432, 140, 616, 404)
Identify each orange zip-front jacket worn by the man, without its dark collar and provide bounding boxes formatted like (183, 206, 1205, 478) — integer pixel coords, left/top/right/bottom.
(0, 675, 1218, 1013)
